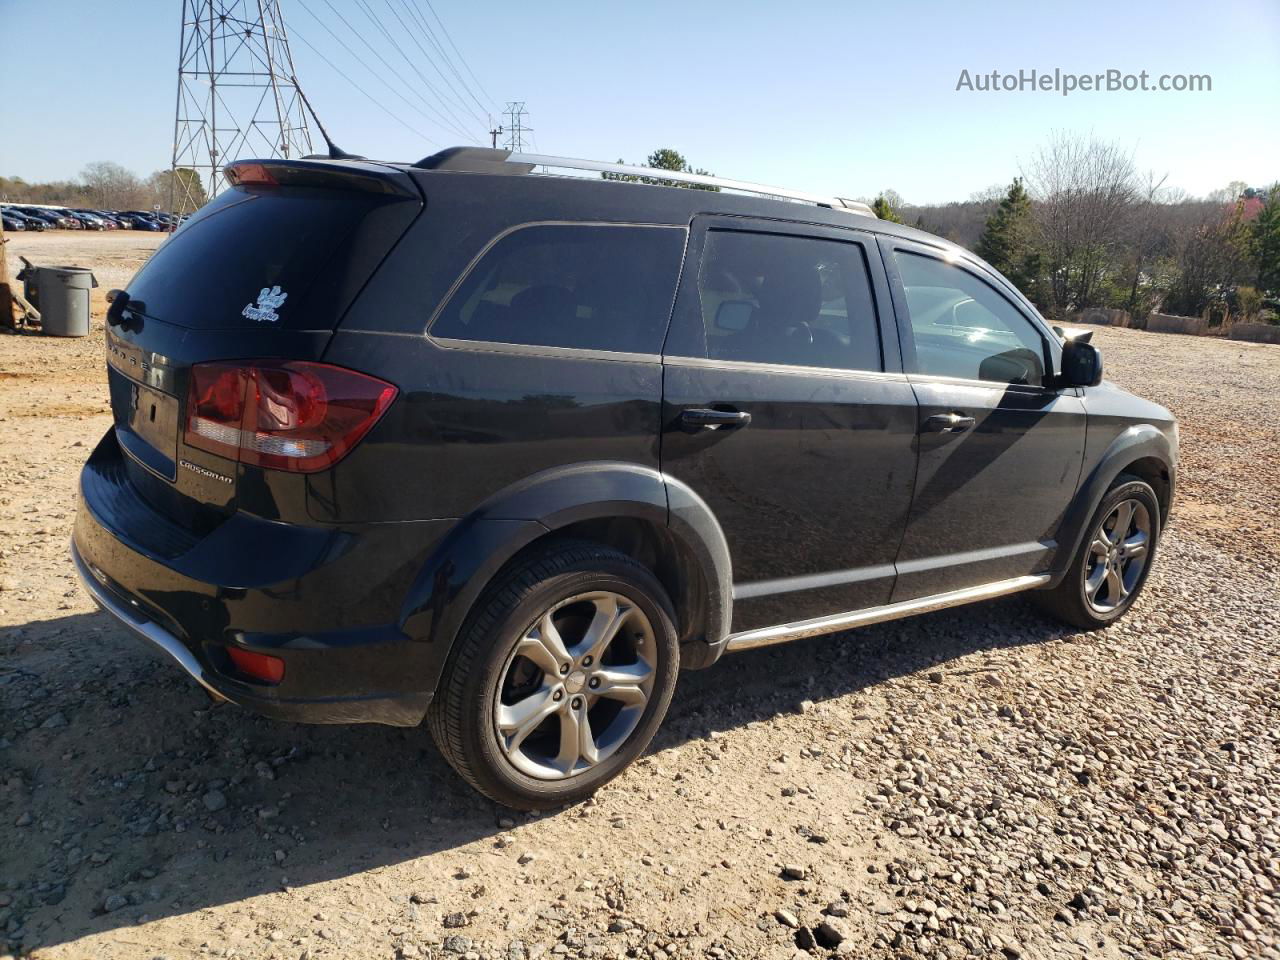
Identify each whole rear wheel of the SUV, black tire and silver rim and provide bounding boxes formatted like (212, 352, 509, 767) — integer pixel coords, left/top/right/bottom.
(428, 541, 680, 810)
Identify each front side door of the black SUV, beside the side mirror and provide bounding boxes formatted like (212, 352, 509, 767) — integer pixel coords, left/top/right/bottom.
(881, 237, 1085, 602)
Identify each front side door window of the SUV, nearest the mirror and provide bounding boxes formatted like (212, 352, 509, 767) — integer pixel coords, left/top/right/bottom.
(895, 251, 1044, 387)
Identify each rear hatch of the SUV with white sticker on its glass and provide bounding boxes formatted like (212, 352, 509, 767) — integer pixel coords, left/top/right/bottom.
(98, 161, 422, 540)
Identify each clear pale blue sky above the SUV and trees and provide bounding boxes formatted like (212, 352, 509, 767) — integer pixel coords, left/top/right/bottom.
(0, 0, 1280, 204)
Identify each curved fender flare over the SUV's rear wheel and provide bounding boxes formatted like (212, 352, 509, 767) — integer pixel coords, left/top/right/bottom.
(398, 461, 733, 690)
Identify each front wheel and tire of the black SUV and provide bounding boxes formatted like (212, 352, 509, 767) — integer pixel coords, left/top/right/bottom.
(1032, 474, 1161, 630)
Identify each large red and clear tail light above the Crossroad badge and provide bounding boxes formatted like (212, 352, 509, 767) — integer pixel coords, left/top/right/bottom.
(183, 360, 396, 474)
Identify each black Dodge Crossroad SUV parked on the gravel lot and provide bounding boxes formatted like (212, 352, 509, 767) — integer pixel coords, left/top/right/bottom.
(73, 148, 1178, 808)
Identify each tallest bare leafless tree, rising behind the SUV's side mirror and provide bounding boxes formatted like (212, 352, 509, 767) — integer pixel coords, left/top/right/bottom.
(1023, 133, 1137, 316)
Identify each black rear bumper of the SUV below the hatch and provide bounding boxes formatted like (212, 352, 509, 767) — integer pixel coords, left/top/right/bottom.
(72, 432, 448, 726)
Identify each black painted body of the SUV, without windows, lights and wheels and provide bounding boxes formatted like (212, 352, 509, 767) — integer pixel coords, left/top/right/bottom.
(67, 163, 1176, 724)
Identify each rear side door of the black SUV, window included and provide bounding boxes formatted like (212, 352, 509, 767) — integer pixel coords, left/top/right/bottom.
(660, 216, 916, 632)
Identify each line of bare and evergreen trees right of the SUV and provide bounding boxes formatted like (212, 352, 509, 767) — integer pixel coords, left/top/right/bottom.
(873, 134, 1280, 325)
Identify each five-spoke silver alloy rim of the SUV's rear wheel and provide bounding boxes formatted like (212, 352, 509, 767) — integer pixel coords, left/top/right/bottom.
(493, 591, 657, 780)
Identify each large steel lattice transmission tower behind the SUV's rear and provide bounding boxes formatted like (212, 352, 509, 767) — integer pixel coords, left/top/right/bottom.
(169, 0, 311, 214)
